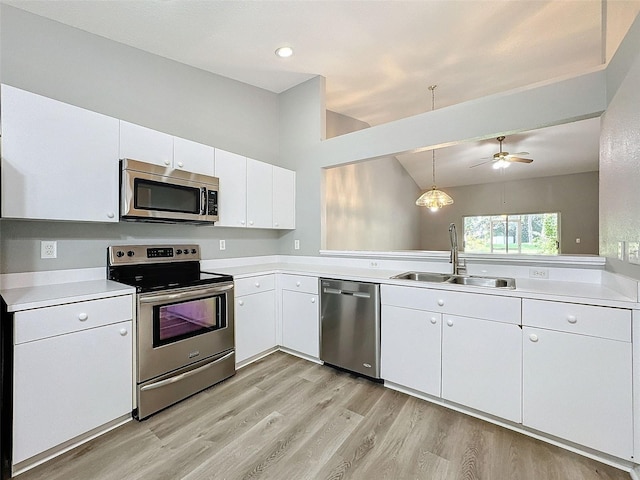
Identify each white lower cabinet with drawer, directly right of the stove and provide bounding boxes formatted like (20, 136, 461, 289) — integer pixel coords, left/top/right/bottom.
(235, 275, 277, 364)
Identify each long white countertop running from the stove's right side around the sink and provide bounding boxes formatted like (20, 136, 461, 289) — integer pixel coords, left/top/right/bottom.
(208, 263, 640, 308)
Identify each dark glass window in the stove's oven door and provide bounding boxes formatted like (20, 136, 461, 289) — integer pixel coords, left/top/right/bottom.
(153, 295, 227, 347)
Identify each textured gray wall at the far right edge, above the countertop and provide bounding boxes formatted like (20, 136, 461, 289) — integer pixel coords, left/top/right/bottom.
(600, 17, 640, 278)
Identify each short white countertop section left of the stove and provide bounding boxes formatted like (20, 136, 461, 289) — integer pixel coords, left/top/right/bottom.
(0, 280, 136, 312)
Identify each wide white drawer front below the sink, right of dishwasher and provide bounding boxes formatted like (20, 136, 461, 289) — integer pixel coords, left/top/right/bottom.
(380, 285, 521, 324)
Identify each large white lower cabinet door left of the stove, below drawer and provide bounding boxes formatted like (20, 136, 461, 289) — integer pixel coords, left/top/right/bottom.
(13, 321, 133, 465)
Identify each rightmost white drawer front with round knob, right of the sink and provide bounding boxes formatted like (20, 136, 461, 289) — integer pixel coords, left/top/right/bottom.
(522, 299, 631, 342)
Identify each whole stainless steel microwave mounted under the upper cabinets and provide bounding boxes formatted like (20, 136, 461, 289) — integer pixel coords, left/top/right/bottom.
(120, 158, 219, 224)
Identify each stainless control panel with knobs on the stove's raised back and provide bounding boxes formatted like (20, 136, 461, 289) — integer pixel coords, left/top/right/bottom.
(107, 245, 200, 265)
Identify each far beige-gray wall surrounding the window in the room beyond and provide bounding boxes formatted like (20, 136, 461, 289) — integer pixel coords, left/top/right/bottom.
(420, 172, 598, 255)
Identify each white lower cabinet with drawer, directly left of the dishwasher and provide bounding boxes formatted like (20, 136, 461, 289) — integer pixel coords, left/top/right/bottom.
(279, 275, 320, 358)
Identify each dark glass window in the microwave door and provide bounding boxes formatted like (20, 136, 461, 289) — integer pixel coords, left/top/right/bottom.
(134, 178, 200, 213)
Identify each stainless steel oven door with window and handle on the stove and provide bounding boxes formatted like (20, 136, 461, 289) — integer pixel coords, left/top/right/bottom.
(137, 282, 234, 383)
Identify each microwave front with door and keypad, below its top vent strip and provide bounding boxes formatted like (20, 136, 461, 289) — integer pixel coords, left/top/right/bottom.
(120, 170, 218, 223)
